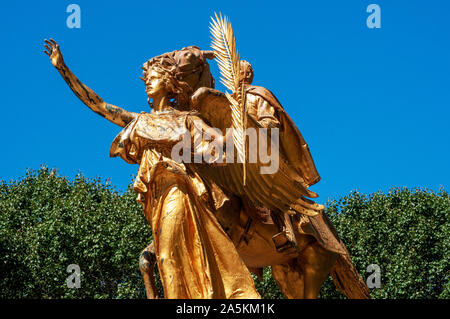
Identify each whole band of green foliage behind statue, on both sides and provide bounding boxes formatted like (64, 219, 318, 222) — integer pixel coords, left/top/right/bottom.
(0, 167, 450, 298)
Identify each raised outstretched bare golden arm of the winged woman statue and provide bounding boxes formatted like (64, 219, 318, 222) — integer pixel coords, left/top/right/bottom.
(44, 39, 137, 127)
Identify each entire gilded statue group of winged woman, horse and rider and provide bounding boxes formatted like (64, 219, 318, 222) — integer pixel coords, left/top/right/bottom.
(44, 11, 369, 299)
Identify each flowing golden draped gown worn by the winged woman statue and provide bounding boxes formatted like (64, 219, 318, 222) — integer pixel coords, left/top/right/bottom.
(110, 112, 260, 299)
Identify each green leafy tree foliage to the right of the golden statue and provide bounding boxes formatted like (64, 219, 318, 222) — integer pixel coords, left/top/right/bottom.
(321, 188, 450, 299)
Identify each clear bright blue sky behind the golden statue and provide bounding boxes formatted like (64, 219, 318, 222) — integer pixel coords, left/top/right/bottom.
(0, 0, 450, 202)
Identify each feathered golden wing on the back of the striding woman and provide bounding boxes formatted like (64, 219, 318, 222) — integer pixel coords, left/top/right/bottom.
(192, 88, 324, 216)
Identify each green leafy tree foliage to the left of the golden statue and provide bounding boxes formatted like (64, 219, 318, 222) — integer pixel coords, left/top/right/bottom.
(0, 168, 152, 298)
